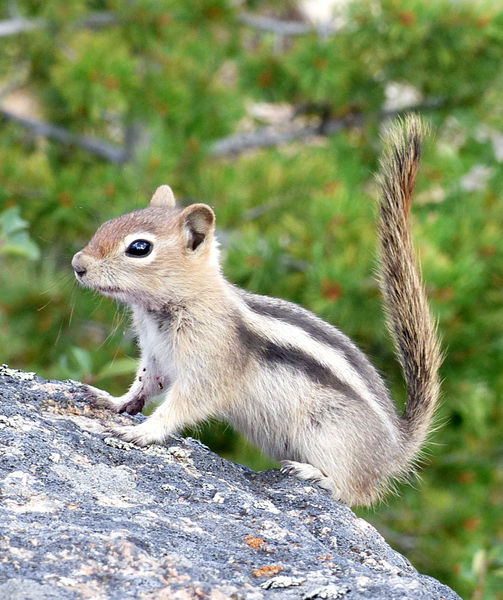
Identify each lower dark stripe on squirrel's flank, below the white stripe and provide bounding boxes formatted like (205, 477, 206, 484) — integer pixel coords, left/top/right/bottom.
(235, 315, 362, 402)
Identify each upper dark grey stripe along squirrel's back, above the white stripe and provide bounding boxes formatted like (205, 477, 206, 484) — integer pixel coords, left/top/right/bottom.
(235, 288, 389, 406)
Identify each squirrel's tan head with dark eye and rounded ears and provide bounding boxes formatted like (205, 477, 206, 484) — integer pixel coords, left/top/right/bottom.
(72, 185, 219, 309)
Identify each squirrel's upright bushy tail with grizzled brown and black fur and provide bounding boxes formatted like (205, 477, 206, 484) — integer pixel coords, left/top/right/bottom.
(377, 115, 442, 460)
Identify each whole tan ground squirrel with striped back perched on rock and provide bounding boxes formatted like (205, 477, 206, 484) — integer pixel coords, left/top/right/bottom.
(72, 116, 441, 505)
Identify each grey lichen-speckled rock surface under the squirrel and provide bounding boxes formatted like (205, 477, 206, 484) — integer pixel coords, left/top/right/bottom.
(0, 367, 458, 600)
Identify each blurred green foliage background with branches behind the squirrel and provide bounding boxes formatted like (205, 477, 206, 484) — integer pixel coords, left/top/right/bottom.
(0, 0, 503, 600)
